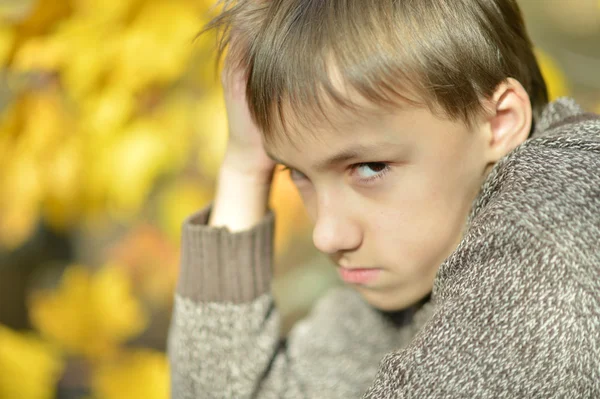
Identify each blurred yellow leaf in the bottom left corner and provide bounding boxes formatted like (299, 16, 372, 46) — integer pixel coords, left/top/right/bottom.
(0, 325, 64, 399)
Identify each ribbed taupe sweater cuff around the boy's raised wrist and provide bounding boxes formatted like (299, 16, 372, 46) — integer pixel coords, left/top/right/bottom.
(177, 207, 275, 303)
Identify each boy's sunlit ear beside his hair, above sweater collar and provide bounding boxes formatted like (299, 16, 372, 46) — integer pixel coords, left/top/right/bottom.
(487, 78, 532, 163)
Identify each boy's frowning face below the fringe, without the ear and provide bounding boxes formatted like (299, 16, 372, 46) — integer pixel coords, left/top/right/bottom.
(267, 101, 488, 310)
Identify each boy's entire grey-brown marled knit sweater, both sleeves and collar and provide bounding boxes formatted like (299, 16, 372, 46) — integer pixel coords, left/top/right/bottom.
(168, 99, 600, 399)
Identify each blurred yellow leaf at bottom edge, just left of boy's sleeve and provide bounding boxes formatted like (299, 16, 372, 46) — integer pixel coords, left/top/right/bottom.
(92, 349, 170, 399)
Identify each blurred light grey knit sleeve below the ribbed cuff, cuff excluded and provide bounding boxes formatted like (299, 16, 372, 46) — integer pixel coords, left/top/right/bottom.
(168, 289, 425, 399)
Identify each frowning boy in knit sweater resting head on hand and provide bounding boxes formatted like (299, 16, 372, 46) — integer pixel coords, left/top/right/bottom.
(169, 0, 600, 399)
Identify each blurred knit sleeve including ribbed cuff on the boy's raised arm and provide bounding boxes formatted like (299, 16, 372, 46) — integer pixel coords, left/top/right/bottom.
(169, 206, 420, 399)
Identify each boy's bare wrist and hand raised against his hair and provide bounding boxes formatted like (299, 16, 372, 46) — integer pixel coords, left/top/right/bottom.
(209, 69, 275, 232)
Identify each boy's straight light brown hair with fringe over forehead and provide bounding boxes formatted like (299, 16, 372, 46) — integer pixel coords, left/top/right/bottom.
(201, 0, 548, 139)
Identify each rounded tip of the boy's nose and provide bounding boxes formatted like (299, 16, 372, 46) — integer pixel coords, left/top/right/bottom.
(313, 208, 362, 254)
